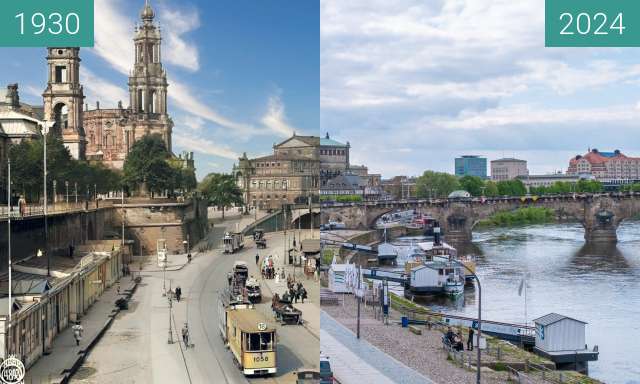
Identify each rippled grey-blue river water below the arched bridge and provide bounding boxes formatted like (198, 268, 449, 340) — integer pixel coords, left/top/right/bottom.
(390, 221, 640, 384)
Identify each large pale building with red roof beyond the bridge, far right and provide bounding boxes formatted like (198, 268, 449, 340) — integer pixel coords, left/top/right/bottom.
(567, 149, 640, 181)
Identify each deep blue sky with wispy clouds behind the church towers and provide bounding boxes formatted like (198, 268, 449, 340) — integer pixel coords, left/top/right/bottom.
(0, 0, 320, 177)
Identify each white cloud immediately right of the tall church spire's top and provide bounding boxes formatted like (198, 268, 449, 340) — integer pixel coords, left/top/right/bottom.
(159, 3, 200, 72)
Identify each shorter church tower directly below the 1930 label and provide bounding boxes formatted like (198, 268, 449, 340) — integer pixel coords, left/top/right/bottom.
(42, 48, 86, 159)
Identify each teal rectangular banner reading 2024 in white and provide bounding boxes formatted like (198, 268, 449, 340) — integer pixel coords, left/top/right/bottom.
(545, 0, 640, 47)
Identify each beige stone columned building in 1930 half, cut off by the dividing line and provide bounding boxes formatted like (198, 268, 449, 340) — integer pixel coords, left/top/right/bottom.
(233, 134, 320, 209)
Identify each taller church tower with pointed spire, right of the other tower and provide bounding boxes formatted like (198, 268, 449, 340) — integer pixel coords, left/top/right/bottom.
(127, 0, 173, 152)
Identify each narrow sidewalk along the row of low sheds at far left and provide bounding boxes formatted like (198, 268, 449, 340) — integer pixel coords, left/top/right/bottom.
(25, 276, 132, 384)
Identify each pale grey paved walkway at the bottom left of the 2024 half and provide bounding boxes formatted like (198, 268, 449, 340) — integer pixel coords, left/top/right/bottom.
(320, 311, 435, 384)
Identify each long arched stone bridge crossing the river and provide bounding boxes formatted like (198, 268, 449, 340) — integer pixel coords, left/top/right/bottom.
(322, 193, 640, 243)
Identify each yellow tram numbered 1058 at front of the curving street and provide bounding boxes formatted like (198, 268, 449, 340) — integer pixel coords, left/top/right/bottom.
(221, 305, 277, 375)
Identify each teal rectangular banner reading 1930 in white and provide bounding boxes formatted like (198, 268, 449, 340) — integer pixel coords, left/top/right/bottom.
(0, 0, 93, 47)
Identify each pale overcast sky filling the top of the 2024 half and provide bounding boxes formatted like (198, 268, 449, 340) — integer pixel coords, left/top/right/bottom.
(320, 0, 640, 177)
